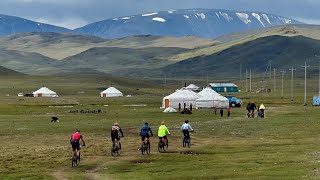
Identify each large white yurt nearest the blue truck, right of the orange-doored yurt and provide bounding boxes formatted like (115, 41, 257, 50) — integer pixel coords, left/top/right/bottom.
(196, 87, 229, 109)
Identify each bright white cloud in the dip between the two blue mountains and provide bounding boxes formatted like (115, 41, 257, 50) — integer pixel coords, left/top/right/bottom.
(29, 18, 88, 29)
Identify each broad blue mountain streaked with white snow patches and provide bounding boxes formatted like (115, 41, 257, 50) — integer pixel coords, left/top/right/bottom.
(75, 9, 301, 38)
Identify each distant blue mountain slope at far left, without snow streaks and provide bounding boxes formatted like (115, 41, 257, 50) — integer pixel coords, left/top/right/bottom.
(0, 14, 71, 35)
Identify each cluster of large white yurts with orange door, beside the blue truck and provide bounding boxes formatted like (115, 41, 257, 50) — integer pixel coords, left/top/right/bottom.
(162, 84, 229, 109)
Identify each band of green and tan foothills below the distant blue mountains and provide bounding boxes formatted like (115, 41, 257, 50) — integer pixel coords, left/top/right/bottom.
(0, 25, 320, 78)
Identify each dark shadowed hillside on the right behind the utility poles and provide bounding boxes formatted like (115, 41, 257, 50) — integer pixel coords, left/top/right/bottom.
(163, 36, 320, 77)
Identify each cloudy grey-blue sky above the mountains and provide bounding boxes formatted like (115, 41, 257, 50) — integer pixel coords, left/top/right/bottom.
(0, 0, 320, 29)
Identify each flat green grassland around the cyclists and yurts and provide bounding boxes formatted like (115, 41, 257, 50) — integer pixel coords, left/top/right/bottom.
(0, 76, 320, 179)
